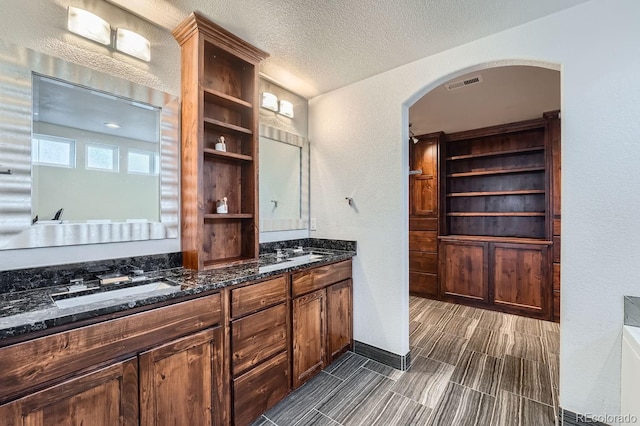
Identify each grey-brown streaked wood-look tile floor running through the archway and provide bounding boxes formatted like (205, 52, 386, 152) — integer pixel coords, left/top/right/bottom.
(254, 297, 560, 426)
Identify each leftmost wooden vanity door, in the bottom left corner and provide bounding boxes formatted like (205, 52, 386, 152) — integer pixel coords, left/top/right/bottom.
(0, 358, 138, 426)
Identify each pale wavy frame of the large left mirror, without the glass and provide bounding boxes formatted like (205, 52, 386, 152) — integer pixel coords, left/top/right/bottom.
(0, 39, 180, 250)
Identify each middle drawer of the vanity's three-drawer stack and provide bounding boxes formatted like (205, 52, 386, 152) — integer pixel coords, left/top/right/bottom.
(231, 303, 287, 375)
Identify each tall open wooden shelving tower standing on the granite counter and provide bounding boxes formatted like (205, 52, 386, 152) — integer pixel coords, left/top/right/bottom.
(173, 13, 268, 270)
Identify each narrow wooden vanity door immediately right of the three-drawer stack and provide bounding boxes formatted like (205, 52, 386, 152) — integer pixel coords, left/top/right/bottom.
(293, 289, 326, 388)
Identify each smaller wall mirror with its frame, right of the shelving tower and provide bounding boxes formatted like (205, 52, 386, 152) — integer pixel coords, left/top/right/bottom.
(259, 125, 309, 232)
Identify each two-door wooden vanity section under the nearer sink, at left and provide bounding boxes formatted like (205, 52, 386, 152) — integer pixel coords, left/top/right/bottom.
(0, 294, 228, 426)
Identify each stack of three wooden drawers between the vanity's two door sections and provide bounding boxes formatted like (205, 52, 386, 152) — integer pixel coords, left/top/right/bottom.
(230, 275, 290, 426)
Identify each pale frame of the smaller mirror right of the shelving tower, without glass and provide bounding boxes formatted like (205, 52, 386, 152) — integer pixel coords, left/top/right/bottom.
(260, 124, 310, 232)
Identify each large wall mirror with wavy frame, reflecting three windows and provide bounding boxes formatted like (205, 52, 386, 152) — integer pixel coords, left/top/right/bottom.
(0, 40, 179, 249)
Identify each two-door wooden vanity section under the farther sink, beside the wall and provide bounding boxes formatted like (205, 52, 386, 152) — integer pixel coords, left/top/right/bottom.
(292, 260, 353, 389)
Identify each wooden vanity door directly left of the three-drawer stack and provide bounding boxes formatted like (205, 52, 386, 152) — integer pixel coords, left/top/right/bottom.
(139, 328, 223, 426)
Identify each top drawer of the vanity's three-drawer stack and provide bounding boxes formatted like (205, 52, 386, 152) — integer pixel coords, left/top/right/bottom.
(231, 275, 287, 318)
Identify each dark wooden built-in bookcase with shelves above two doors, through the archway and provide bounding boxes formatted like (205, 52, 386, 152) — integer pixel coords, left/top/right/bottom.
(438, 111, 560, 319)
